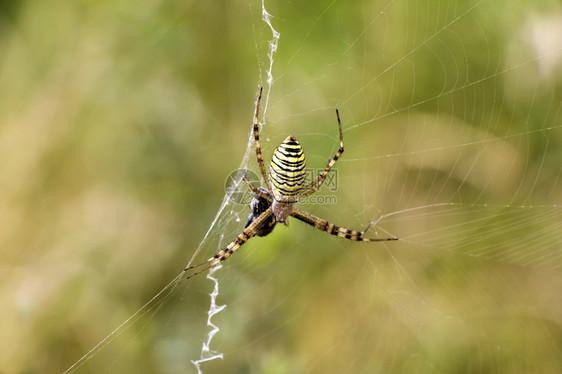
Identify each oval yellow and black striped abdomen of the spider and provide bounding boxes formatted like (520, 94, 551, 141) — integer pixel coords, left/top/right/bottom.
(269, 136, 306, 202)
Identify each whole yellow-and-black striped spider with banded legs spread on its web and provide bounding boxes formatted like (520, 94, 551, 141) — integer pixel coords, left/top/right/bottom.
(184, 87, 398, 279)
